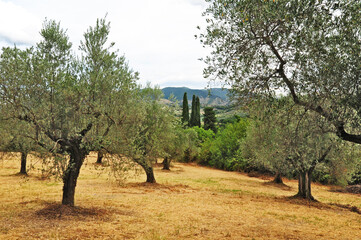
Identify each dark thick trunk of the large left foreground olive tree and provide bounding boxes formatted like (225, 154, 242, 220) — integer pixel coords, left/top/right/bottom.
(62, 147, 86, 206)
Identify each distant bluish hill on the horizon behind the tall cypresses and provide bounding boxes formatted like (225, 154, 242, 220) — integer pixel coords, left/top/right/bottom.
(162, 87, 229, 106)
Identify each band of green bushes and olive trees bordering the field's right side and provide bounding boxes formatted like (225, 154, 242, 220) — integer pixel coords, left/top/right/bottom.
(180, 94, 361, 199)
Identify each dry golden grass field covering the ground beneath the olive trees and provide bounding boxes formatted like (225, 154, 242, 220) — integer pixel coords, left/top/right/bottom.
(0, 153, 361, 240)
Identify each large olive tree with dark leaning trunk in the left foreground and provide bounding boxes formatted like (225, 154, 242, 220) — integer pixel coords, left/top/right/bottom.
(0, 19, 137, 205)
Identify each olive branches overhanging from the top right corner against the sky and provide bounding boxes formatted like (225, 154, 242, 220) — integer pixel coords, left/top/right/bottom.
(200, 0, 361, 144)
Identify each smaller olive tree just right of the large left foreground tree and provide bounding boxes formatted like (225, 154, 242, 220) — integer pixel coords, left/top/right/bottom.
(112, 85, 179, 183)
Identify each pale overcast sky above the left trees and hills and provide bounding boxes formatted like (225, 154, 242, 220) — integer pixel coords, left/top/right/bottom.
(0, 0, 214, 88)
